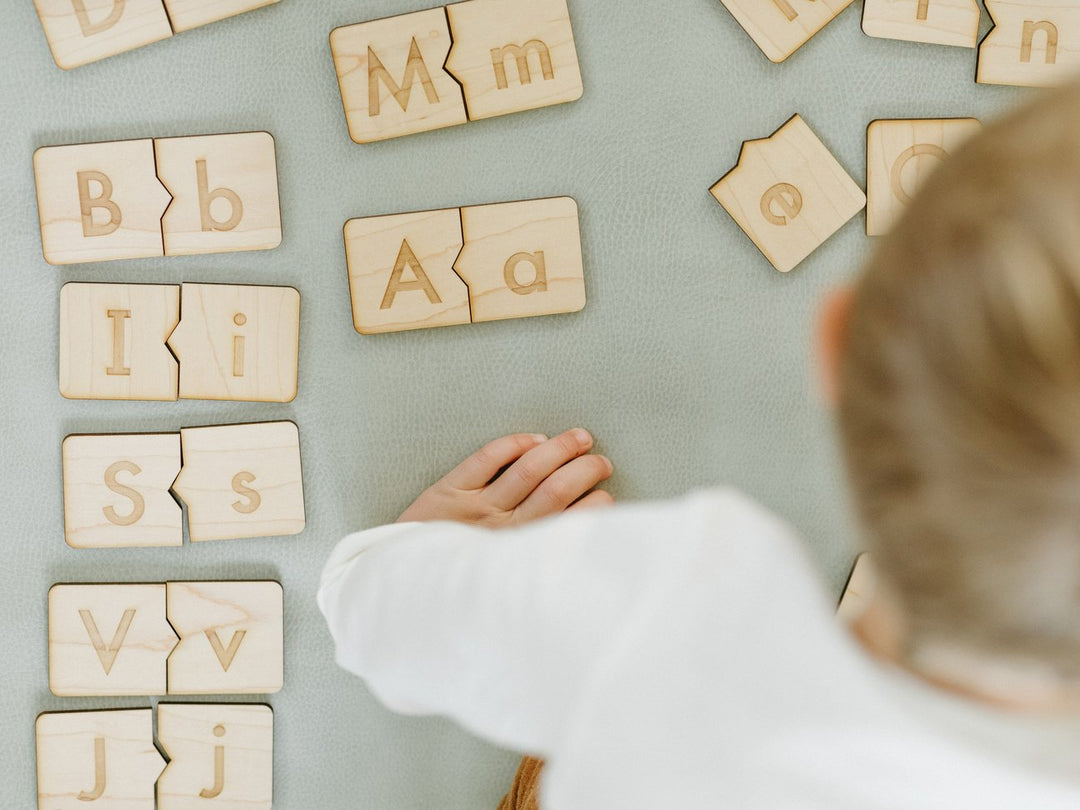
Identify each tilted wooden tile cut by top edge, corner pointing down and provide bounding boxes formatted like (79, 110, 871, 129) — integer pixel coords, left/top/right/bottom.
(720, 0, 853, 62)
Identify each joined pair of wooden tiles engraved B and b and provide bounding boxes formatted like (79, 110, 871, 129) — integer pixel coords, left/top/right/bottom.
(33, 132, 281, 265)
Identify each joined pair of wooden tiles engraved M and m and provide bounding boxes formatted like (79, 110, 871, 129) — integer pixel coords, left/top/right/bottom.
(330, 0, 583, 144)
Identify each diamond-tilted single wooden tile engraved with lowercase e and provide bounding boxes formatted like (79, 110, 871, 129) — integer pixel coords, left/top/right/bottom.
(711, 116, 866, 273)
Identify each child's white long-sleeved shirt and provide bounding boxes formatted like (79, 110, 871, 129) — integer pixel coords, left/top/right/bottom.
(319, 490, 1080, 810)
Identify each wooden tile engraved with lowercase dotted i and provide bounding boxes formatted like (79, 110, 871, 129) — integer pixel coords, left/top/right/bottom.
(168, 284, 300, 403)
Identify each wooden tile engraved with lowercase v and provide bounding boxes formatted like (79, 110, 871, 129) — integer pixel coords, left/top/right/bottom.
(166, 582, 284, 694)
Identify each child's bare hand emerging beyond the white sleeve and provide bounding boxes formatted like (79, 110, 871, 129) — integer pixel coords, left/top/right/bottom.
(397, 429, 615, 527)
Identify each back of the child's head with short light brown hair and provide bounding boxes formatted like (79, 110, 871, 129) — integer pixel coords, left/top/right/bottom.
(837, 86, 1080, 683)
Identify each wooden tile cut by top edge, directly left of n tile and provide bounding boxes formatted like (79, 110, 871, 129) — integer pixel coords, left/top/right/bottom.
(863, 0, 982, 48)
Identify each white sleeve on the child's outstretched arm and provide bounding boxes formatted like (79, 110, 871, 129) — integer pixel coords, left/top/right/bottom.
(319, 492, 717, 756)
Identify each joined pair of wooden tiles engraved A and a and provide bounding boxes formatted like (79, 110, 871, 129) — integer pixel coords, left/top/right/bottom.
(345, 197, 585, 335)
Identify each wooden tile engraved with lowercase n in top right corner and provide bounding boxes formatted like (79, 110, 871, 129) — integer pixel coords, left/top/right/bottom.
(975, 0, 1080, 87)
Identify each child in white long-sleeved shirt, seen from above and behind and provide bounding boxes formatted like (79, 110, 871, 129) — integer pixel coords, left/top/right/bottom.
(320, 87, 1080, 810)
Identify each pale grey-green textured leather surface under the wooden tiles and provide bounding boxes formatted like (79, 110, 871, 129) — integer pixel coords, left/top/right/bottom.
(0, 0, 1021, 810)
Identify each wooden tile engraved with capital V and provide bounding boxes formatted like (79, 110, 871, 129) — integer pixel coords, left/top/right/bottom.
(49, 584, 177, 697)
